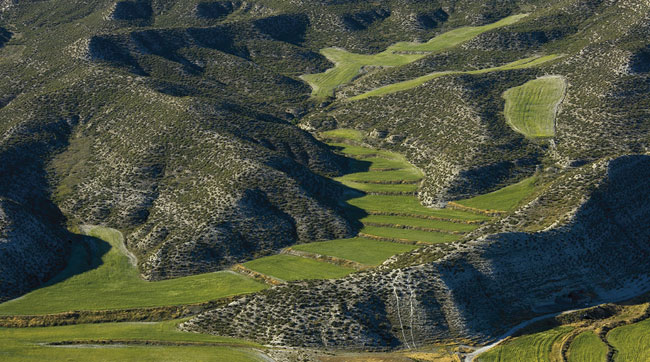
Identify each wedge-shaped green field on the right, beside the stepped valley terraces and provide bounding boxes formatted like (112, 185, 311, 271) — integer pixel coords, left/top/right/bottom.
(456, 176, 537, 211)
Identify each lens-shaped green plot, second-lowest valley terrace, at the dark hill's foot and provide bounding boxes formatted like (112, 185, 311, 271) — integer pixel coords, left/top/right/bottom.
(291, 238, 417, 265)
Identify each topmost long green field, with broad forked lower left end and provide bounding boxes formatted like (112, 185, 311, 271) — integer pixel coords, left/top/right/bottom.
(301, 14, 527, 98)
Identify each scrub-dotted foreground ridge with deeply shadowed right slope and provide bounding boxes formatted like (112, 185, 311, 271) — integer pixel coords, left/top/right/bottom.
(182, 156, 650, 348)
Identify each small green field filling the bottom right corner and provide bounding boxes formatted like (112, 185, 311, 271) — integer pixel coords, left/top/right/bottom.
(607, 319, 650, 362)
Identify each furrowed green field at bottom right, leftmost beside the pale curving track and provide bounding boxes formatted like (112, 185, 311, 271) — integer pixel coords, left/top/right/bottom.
(477, 327, 573, 362)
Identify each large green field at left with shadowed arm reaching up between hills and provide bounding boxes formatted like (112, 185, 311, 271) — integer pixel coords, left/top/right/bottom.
(0, 227, 266, 315)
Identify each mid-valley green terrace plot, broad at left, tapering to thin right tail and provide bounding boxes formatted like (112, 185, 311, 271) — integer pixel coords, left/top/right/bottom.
(347, 195, 491, 221)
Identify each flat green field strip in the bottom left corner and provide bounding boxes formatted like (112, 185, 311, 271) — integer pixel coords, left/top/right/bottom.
(0, 321, 263, 362)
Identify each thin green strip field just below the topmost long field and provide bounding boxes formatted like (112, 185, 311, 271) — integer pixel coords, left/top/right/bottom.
(350, 54, 559, 101)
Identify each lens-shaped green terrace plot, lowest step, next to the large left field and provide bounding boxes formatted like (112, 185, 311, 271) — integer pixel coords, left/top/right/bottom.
(244, 255, 354, 281)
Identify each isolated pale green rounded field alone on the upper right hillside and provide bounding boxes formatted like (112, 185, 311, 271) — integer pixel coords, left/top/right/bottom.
(503, 76, 566, 138)
